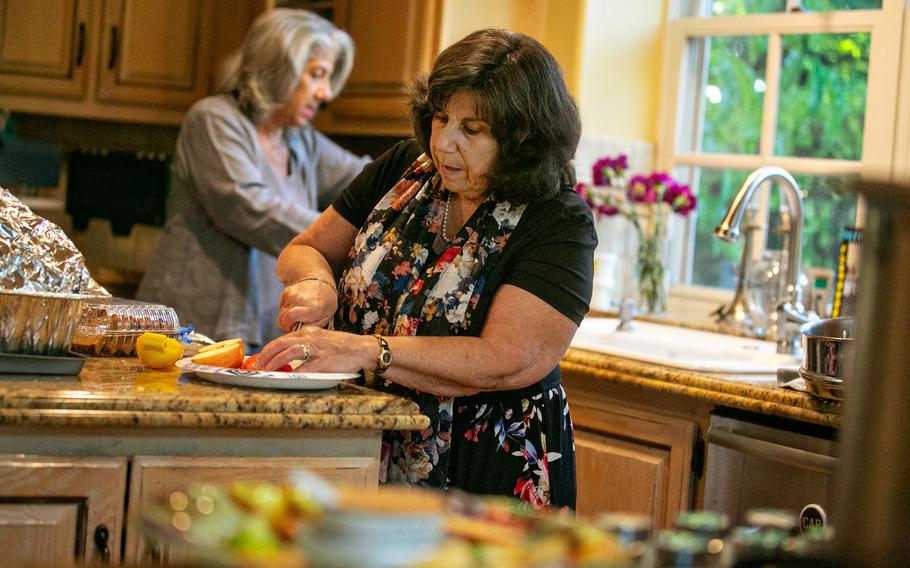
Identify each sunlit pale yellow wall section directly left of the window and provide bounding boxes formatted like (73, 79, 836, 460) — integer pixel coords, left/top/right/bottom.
(579, 0, 668, 142)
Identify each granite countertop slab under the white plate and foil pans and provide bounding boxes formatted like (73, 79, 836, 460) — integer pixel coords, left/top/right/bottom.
(0, 358, 429, 430)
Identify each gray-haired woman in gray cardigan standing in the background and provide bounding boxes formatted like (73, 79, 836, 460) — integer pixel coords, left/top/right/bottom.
(137, 9, 367, 350)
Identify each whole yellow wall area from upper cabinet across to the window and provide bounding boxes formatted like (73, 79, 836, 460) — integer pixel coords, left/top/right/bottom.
(440, 0, 668, 142)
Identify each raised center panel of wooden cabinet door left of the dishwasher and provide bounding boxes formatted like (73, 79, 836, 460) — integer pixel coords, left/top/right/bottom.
(575, 429, 670, 519)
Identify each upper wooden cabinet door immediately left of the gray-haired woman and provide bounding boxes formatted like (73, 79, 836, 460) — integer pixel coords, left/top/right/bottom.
(98, 0, 214, 108)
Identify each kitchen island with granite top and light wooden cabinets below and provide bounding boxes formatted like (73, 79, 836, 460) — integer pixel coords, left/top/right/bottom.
(0, 358, 429, 566)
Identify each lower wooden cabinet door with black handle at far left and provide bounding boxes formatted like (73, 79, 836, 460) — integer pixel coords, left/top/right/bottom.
(0, 456, 127, 566)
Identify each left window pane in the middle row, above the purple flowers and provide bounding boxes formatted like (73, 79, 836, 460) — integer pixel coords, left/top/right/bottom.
(700, 36, 768, 154)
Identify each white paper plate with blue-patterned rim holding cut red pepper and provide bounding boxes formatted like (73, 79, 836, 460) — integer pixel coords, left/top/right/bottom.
(176, 358, 358, 390)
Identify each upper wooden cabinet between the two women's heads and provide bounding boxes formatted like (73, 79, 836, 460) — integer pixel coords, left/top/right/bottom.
(316, 0, 442, 135)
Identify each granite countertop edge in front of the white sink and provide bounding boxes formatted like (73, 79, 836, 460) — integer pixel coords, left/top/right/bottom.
(561, 348, 842, 428)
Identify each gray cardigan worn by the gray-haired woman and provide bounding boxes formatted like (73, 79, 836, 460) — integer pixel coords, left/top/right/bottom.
(137, 95, 368, 348)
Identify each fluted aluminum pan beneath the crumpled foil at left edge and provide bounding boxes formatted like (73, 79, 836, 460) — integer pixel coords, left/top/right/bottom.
(0, 290, 100, 356)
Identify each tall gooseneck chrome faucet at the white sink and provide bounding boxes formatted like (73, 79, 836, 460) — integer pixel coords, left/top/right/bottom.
(714, 166, 815, 354)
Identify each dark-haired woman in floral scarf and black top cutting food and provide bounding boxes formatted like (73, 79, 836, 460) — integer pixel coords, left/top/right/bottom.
(259, 30, 597, 507)
